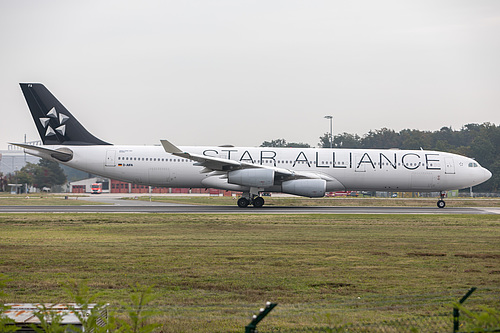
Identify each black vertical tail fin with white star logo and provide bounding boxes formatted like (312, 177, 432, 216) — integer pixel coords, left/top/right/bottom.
(20, 83, 110, 146)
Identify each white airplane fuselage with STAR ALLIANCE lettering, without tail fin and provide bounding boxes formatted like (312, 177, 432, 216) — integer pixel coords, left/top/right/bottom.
(27, 145, 491, 192)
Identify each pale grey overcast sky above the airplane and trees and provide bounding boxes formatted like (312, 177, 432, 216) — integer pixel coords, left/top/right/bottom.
(0, 0, 500, 149)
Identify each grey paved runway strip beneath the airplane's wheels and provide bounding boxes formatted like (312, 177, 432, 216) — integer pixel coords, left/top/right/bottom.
(0, 202, 500, 215)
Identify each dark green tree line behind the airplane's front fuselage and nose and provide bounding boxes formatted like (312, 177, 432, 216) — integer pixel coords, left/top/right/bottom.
(261, 122, 500, 192)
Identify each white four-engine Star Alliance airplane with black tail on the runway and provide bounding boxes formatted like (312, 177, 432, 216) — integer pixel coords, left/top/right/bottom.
(13, 83, 491, 208)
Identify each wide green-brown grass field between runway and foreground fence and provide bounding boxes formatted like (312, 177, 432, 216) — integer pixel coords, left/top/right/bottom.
(0, 214, 500, 332)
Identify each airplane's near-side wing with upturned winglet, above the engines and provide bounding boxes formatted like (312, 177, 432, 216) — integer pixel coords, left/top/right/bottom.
(160, 140, 333, 181)
